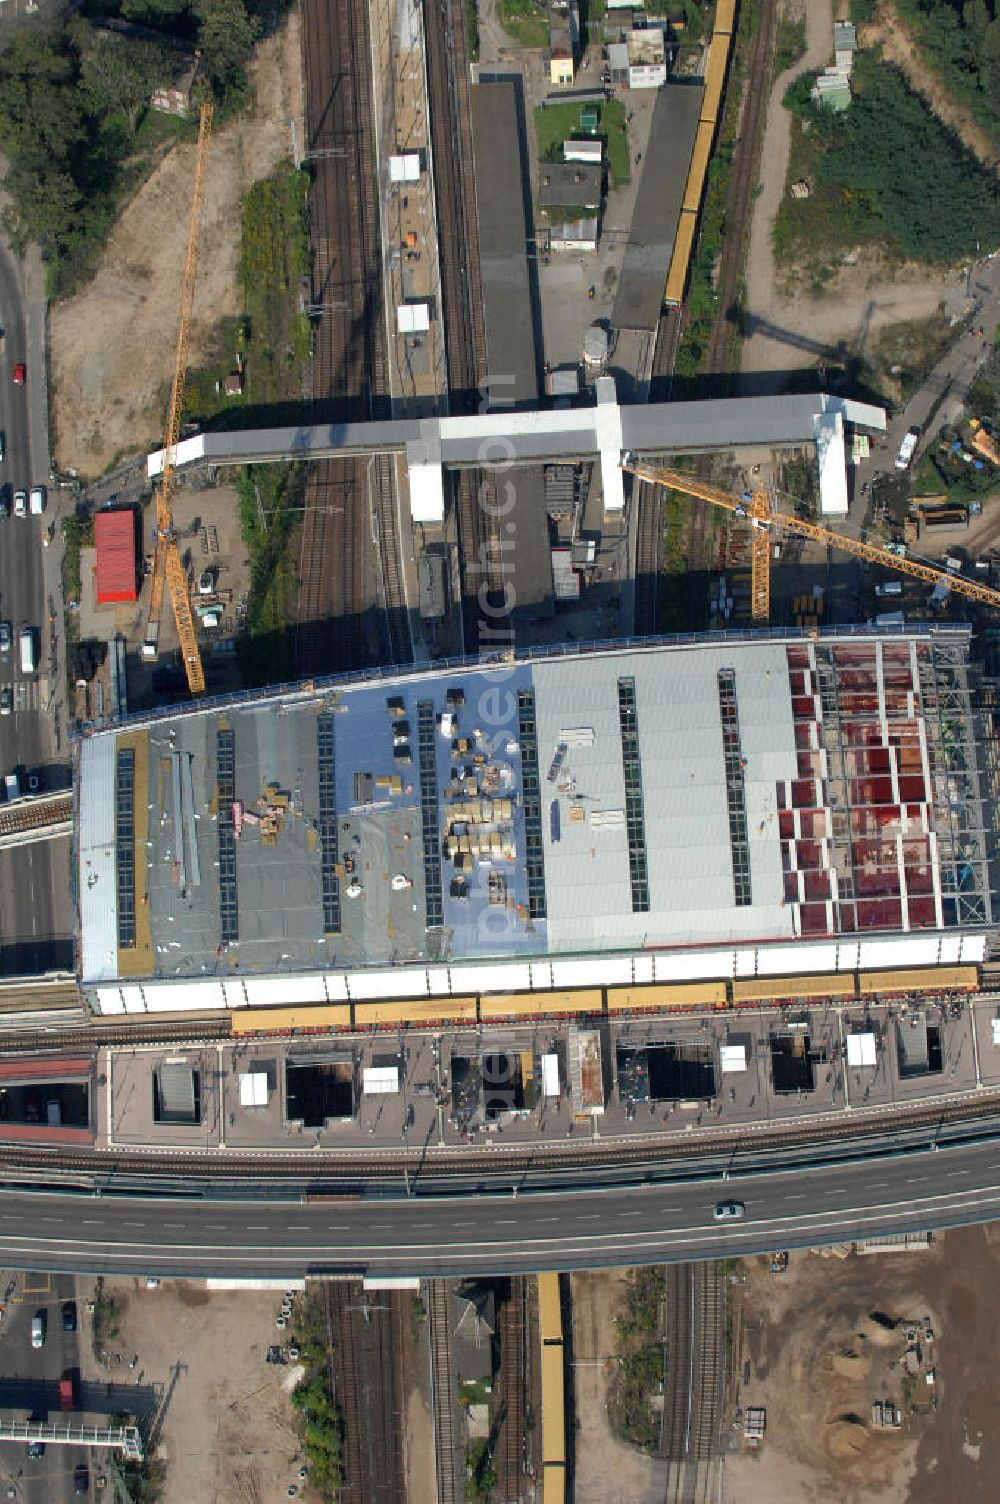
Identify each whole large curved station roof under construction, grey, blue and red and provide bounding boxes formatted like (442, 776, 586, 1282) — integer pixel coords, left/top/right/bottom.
(75, 626, 992, 1012)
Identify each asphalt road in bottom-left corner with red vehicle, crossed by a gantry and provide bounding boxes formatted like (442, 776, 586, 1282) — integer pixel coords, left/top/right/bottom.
(0, 1275, 87, 1504)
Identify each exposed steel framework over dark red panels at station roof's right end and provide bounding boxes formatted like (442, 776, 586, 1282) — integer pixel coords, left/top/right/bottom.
(782, 630, 992, 934)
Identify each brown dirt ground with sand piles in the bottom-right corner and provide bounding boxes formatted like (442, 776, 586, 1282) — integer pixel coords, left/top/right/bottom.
(723, 1227, 1000, 1504)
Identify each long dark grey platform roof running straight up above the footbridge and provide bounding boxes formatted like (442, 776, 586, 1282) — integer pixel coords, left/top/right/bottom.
(471, 83, 538, 403)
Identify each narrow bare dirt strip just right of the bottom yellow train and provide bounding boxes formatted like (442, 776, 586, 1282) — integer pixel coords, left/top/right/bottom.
(570, 1269, 666, 1504)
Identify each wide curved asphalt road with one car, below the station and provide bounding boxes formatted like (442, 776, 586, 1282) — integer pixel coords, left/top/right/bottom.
(0, 1139, 1000, 1278)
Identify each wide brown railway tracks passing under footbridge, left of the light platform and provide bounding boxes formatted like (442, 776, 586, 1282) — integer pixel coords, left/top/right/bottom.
(295, 0, 412, 675)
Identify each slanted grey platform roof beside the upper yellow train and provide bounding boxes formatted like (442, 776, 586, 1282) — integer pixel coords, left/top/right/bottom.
(611, 80, 705, 329)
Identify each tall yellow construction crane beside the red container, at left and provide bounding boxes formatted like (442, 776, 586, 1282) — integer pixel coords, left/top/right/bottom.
(143, 101, 212, 695)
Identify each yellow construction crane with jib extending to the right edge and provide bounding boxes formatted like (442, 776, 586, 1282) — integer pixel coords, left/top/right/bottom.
(623, 459, 1000, 621)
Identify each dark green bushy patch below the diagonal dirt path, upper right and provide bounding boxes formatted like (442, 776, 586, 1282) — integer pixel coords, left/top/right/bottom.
(774, 53, 1000, 286)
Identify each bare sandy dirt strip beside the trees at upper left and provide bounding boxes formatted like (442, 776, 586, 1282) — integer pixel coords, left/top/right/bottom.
(50, 12, 304, 478)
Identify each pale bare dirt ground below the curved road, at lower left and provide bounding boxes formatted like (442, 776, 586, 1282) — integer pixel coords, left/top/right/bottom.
(80, 1278, 307, 1504)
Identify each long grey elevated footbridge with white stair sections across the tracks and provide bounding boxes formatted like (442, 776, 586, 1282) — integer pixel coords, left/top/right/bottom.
(146, 388, 886, 522)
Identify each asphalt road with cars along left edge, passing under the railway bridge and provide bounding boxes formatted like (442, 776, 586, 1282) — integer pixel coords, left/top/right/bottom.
(0, 244, 72, 976)
